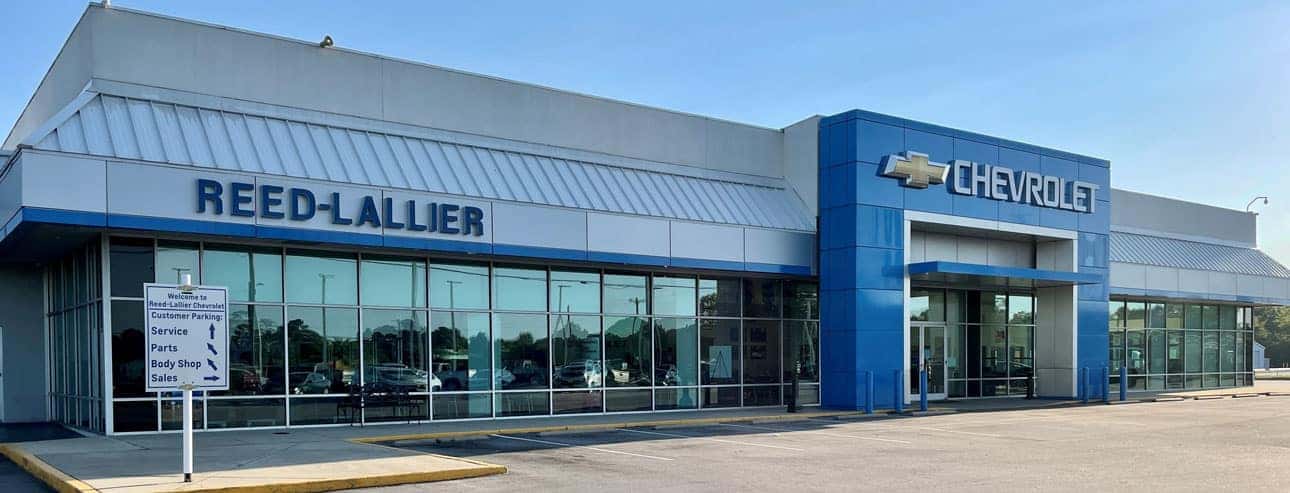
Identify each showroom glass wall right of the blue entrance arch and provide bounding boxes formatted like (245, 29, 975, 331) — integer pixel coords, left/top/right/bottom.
(1109, 299, 1254, 390)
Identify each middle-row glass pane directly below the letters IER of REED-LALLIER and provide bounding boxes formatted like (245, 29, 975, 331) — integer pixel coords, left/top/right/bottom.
(430, 311, 493, 389)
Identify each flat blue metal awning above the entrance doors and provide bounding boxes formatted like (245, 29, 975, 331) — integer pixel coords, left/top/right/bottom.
(908, 261, 1103, 288)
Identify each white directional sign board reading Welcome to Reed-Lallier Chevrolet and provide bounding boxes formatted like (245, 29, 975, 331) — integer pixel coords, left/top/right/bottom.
(143, 284, 228, 392)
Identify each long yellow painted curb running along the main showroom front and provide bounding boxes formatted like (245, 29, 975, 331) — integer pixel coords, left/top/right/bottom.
(350, 410, 857, 444)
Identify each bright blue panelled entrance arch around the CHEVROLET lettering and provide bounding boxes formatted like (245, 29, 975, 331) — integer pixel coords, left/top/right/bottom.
(819, 110, 1111, 409)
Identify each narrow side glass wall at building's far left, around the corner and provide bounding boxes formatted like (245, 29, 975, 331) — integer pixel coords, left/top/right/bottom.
(45, 237, 103, 431)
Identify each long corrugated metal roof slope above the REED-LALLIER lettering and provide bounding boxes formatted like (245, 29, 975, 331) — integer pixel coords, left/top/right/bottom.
(34, 94, 814, 231)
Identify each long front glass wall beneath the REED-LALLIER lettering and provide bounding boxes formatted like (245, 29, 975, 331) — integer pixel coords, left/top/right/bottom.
(108, 237, 819, 432)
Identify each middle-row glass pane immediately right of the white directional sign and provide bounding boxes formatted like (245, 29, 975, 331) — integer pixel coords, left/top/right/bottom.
(220, 305, 286, 395)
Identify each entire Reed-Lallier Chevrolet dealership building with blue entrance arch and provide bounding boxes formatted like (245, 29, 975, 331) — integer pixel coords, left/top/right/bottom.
(0, 5, 1290, 434)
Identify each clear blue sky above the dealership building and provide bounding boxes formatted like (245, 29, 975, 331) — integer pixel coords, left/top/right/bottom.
(0, 0, 1290, 258)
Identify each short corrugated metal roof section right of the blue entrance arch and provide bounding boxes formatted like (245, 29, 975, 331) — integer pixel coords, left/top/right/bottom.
(1111, 232, 1290, 277)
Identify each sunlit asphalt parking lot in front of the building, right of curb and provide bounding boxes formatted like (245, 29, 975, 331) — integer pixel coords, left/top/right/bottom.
(358, 396, 1290, 492)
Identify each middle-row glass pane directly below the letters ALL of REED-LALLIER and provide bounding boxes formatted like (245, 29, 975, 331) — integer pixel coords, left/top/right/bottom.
(362, 308, 428, 392)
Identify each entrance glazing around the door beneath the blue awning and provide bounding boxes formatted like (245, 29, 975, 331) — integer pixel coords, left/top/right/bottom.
(909, 287, 1035, 397)
